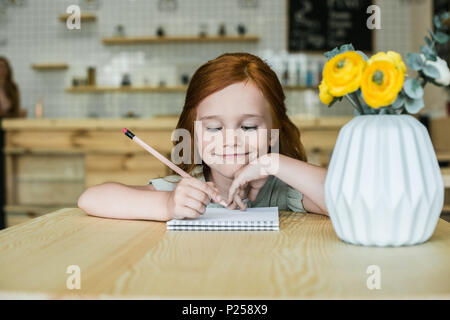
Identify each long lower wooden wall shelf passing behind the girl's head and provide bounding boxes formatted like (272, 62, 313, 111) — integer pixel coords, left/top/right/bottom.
(66, 85, 317, 93)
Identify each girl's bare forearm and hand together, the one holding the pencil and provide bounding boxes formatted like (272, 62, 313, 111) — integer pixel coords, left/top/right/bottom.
(78, 177, 222, 221)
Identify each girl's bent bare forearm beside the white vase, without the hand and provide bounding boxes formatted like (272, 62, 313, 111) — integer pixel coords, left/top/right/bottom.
(272, 154, 328, 215)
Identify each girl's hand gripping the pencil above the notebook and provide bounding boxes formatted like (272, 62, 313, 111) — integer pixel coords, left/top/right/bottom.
(167, 177, 222, 219)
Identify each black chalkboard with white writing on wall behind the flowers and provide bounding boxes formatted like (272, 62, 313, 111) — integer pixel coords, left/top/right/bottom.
(288, 0, 373, 52)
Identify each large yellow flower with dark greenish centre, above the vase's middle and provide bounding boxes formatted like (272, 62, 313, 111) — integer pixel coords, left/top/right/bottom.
(361, 58, 406, 108)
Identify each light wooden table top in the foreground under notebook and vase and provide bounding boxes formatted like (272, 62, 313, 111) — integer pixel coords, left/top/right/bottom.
(0, 208, 450, 299)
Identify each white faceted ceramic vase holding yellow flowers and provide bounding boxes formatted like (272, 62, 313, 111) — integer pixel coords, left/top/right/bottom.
(325, 115, 444, 246)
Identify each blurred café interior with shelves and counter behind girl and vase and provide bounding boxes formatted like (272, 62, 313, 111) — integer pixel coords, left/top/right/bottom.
(0, 0, 450, 226)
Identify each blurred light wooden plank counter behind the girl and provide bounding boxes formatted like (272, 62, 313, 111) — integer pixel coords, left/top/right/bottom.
(2, 116, 351, 226)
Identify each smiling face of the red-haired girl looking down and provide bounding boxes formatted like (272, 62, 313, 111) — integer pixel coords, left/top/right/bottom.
(195, 81, 272, 178)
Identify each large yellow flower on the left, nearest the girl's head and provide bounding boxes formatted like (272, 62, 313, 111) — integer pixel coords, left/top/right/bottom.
(323, 51, 366, 97)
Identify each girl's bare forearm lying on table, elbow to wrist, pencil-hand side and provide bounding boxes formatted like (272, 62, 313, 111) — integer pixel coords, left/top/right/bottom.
(78, 182, 171, 221)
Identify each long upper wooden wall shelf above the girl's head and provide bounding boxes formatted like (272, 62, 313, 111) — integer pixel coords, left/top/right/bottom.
(103, 35, 259, 45)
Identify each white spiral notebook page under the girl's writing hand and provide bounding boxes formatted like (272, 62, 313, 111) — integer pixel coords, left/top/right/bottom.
(167, 207, 279, 229)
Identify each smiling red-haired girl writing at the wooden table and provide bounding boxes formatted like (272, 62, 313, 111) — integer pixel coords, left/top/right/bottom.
(78, 53, 328, 221)
